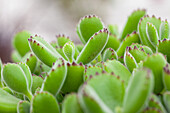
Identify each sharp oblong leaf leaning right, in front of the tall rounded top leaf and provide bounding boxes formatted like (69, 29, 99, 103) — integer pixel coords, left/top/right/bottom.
(76, 28, 109, 64)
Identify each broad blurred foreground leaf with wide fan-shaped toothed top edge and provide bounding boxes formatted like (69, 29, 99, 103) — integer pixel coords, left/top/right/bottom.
(79, 74, 125, 113)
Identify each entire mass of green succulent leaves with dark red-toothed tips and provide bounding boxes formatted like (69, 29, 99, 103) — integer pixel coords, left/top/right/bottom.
(0, 9, 170, 113)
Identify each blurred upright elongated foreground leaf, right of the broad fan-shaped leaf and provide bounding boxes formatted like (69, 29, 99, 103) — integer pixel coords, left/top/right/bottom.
(123, 69, 154, 113)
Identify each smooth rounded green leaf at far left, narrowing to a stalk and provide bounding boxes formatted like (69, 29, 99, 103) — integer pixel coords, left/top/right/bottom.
(2, 63, 32, 99)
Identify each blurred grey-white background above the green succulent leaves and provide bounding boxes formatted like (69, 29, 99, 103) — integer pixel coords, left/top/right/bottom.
(0, 0, 170, 62)
